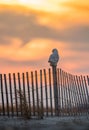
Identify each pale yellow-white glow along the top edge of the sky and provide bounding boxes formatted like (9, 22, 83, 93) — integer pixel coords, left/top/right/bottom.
(0, 0, 69, 13)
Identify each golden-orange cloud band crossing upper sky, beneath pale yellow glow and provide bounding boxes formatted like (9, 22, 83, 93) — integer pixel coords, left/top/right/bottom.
(0, 1, 89, 30)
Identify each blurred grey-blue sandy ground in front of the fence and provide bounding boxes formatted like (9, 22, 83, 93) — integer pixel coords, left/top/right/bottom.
(0, 116, 89, 130)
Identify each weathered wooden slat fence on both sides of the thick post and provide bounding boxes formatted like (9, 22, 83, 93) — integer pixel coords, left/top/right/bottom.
(0, 69, 89, 117)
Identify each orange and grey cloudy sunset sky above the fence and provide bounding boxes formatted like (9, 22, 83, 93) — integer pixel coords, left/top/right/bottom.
(0, 0, 89, 75)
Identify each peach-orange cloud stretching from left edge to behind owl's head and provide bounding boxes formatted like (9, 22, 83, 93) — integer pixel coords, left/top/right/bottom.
(0, 38, 67, 61)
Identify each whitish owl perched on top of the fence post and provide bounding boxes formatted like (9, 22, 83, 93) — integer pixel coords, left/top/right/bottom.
(48, 49, 59, 66)
